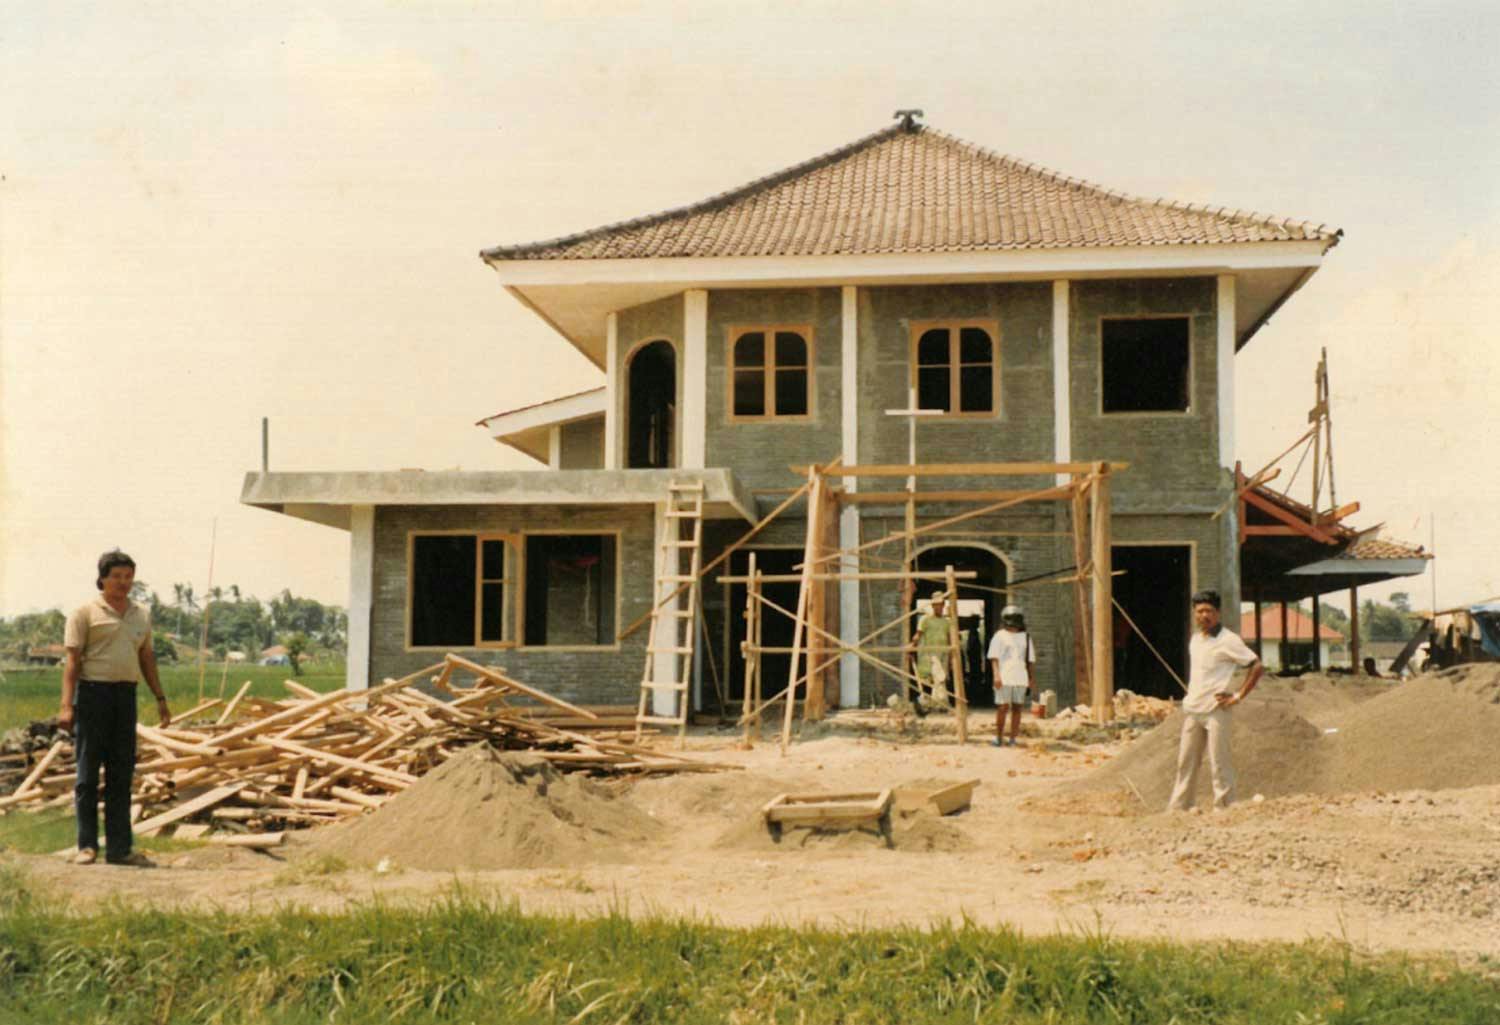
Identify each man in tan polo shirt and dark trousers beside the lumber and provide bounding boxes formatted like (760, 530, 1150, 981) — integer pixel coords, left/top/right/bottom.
(57, 548, 171, 866)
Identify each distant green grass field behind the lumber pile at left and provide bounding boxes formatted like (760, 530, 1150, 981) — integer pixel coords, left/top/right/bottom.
(0, 663, 344, 731)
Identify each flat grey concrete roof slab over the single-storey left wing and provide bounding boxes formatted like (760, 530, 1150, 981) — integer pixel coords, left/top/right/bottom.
(249, 467, 756, 530)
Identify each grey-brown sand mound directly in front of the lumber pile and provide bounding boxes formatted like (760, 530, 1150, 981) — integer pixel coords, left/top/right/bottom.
(311, 744, 660, 869)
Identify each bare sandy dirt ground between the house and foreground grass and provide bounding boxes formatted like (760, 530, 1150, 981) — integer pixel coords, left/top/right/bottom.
(21, 720, 1500, 956)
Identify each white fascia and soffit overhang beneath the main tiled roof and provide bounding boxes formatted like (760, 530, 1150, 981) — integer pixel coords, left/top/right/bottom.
(485, 240, 1334, 368)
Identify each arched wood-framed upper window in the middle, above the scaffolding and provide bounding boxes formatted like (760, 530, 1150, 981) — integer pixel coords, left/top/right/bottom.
(912, 321, 1001, 416)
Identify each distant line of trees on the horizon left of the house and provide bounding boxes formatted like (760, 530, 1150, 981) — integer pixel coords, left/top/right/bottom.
(0, 581, 350, 666)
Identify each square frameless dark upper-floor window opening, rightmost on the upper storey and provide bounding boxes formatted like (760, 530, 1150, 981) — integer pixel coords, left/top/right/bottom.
(1100, 317, 1191, 413)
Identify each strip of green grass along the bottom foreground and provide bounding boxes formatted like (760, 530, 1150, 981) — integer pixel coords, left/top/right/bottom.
(0, 878, 1500, 1025)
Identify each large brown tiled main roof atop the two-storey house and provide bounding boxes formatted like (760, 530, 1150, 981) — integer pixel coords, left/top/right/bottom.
(482, 126, 1343, 260)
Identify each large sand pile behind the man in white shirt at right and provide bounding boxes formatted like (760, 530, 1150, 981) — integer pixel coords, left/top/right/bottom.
(1061, 663, 1500, 812)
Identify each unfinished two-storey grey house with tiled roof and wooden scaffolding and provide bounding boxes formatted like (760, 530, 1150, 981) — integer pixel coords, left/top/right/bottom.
(242, 113, 1425, 725)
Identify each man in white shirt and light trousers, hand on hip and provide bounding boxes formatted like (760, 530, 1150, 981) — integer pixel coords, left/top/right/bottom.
(1167, 591, 1263, 812)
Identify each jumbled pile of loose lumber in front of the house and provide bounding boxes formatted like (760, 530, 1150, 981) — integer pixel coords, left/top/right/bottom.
(0, 654, 735, 846)
